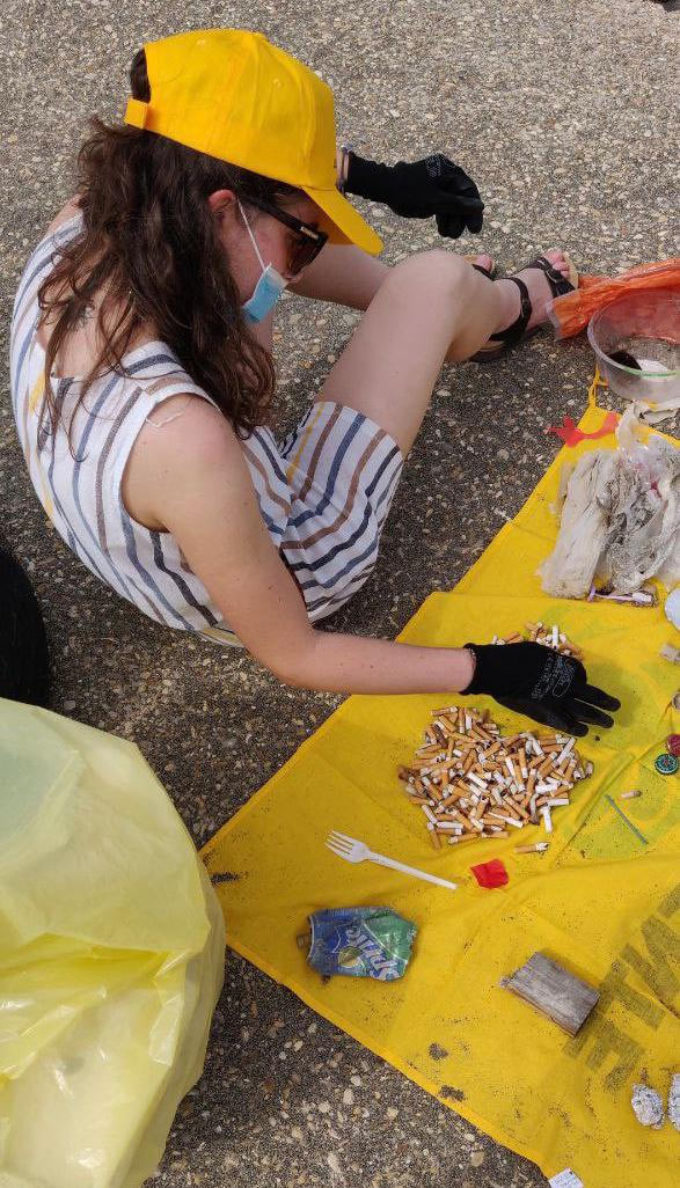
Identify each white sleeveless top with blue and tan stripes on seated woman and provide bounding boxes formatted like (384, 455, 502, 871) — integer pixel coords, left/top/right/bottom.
(10, 215, 290, 643)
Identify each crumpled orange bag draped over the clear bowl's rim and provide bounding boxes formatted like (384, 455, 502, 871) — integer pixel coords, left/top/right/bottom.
(548, 255, 680, 339)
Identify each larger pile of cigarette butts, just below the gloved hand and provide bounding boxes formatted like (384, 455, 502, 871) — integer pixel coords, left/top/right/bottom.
(398, 706, 593, 849)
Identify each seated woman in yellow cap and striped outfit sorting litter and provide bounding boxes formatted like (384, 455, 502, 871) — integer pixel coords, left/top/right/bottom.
(12, 30, 618, 733)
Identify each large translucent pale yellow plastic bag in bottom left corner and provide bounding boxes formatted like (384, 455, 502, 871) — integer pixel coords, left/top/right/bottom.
(0, 700, 225, 1188)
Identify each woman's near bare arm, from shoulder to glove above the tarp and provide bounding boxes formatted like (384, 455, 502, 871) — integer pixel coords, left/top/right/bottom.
(137, 402, 473, 694)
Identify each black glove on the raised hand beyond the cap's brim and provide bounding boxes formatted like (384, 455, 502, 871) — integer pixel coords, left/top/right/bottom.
(345, 152, 484, 239)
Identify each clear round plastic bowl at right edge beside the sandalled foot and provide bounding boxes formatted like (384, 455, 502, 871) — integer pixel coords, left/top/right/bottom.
(588, 289, 680, 403)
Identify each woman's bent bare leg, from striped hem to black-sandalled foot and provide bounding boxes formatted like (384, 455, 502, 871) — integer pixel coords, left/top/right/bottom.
(317, 251, 566, 455)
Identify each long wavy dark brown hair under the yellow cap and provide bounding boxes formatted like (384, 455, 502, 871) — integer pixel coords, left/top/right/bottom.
(39, 50, 300, 438)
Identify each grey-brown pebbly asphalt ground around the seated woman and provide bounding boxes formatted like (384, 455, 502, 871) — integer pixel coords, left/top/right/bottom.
(0, 0, 680, 1188)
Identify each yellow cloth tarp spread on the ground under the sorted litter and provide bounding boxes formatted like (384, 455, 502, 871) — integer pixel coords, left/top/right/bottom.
(204, 409, 680, 1188)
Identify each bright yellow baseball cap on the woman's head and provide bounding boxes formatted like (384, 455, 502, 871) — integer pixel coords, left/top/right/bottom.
(125, 29, 383, 255)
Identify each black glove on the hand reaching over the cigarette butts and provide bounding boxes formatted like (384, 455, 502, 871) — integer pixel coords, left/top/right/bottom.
(462, 643, 621, 735)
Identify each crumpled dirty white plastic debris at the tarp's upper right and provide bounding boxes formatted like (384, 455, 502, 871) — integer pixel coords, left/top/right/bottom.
(541, 407, 680, 598)
